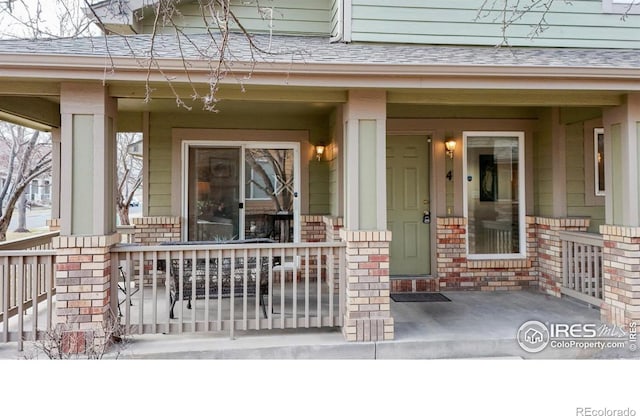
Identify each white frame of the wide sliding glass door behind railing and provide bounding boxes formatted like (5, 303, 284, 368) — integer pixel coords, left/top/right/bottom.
(180, 140, 301, 243)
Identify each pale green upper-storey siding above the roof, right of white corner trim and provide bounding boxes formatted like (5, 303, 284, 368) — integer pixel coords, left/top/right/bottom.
(351, 0, 640, 48)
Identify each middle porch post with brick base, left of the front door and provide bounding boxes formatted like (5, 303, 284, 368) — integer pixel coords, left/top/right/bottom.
(340, 90, 394, 341)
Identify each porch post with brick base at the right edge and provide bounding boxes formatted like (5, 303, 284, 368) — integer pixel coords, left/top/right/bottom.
(600, 93, 640, 327)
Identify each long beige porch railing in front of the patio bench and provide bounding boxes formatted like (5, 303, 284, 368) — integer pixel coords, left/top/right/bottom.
(111, 243, 345, 337)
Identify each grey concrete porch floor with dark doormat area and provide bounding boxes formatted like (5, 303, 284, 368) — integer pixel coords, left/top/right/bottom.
(0, 291, 640, 359)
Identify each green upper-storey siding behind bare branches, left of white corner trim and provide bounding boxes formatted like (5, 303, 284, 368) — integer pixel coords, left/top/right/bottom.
(142, 0, 332, 36)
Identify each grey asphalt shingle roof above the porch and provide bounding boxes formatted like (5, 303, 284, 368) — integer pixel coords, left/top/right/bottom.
(0, 34, 640, 68)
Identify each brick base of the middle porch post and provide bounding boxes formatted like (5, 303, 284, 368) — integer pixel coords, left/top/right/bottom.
(340, 229, 394, 341)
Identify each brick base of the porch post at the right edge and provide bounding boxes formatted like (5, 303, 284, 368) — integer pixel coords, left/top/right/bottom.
(600, 225, 640, 327)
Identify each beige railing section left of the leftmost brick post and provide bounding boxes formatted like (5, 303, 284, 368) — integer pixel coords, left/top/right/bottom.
(0, 250, 55, 350)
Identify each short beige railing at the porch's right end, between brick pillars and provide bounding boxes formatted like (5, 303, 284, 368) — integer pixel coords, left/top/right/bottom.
(559, 231, 604, 307)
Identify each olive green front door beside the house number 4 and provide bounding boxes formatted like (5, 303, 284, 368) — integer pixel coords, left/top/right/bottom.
(387, 136, 431, 275)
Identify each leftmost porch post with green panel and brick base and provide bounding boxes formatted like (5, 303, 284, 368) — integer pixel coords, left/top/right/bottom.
(54, 83, 119, 353)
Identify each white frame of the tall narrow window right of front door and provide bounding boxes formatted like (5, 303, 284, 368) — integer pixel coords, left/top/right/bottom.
(462, 131, 527, 260)
